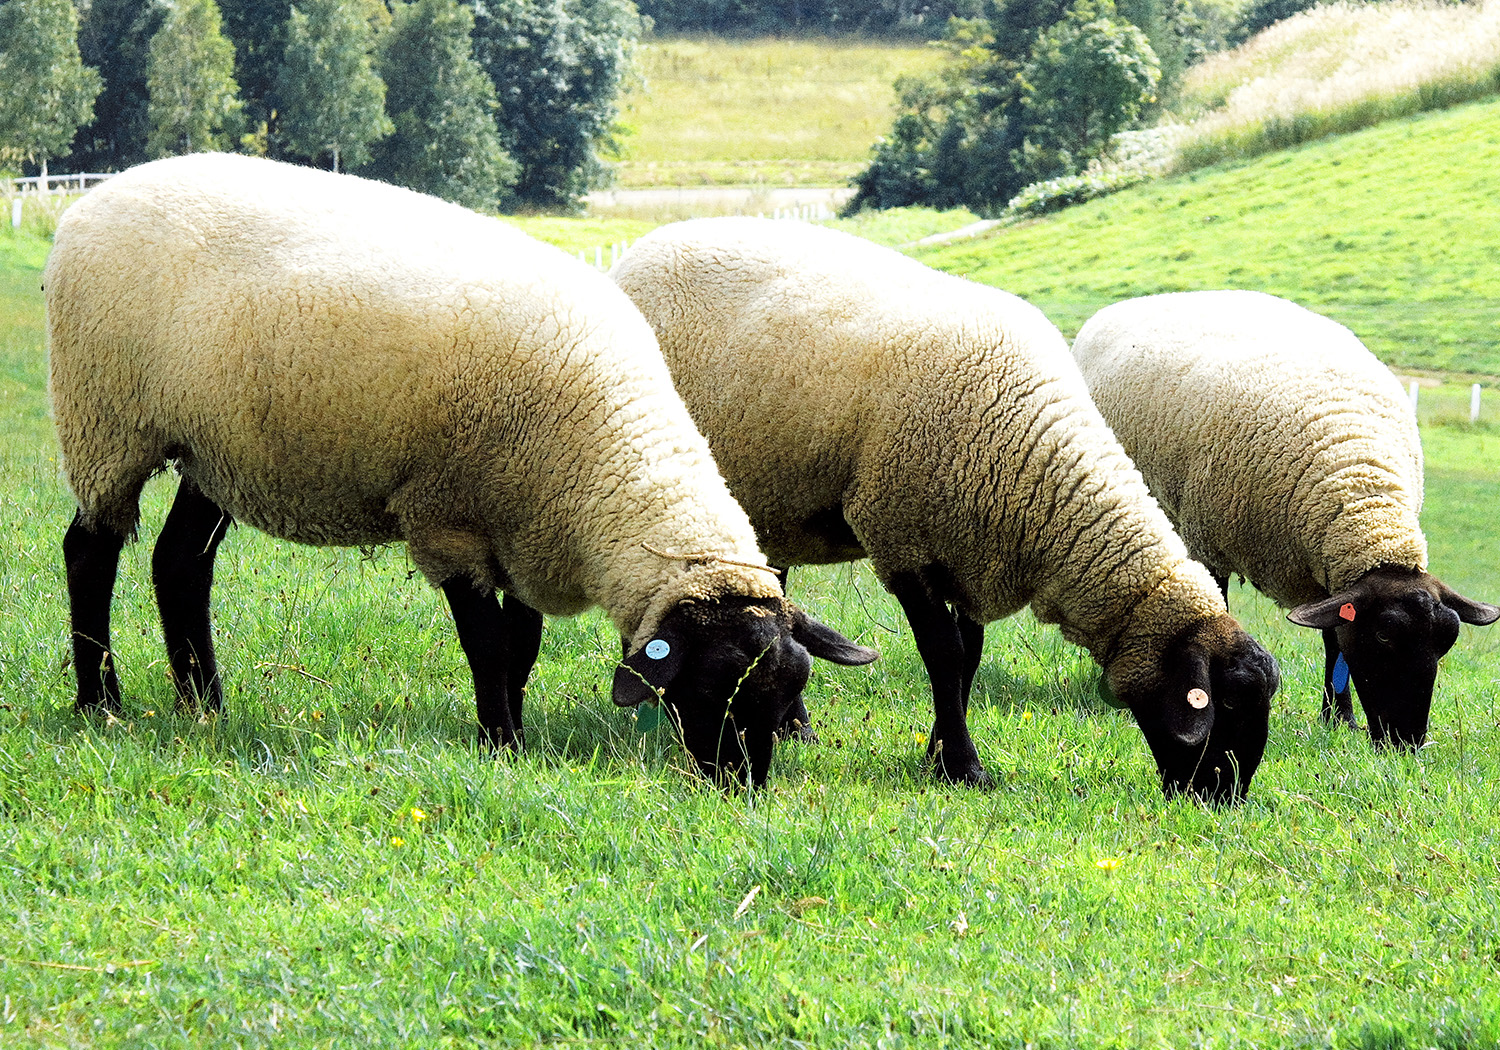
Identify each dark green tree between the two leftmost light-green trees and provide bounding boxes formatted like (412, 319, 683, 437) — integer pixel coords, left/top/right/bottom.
(68, 0, 167, 171)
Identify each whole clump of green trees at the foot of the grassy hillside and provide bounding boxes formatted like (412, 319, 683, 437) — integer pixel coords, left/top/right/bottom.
(849, 0, 1164, 215)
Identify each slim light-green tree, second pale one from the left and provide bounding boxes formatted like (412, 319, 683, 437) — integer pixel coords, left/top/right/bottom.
(146, 0, 240, 158)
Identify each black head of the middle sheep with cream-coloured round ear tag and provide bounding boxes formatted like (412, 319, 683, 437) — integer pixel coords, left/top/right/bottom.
(1119, 615, 1281, 803)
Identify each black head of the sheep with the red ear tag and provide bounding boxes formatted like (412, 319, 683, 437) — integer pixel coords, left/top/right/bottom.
(1287, 566, 1500, 747)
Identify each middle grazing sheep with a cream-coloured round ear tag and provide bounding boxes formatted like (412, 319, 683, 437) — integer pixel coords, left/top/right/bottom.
(614, 219, 1278, 801)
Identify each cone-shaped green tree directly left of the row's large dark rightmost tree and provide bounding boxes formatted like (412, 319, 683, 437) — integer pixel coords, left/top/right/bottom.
(362, 0, 518, 209)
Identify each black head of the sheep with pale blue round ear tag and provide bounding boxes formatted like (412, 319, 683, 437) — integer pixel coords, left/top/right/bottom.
(614, 599, 879, 785)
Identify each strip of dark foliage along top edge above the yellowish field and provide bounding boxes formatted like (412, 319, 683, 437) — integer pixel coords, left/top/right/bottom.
(638, 0, 984, 38)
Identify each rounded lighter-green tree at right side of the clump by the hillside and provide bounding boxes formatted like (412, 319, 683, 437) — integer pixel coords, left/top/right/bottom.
(1011, 0, 1161, 183)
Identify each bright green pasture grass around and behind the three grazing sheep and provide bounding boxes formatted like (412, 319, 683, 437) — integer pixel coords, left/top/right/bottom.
(0, 108, 1500, 1050)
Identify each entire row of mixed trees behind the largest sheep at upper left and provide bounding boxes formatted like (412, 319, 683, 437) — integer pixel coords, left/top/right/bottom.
(0, 0, 641, 210)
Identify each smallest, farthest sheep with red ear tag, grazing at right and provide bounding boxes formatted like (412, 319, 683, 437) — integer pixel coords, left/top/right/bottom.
(1073, 291, 1500, 747)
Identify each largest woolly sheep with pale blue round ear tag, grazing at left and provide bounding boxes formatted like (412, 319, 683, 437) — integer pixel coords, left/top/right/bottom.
(44, 155, 876, 783)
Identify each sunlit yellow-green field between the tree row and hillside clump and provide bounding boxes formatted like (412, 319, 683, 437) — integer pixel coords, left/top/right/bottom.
(620, 39, 942, 188)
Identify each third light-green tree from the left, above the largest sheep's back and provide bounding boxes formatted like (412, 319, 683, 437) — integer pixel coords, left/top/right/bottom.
(276, 0, 392, 171)
